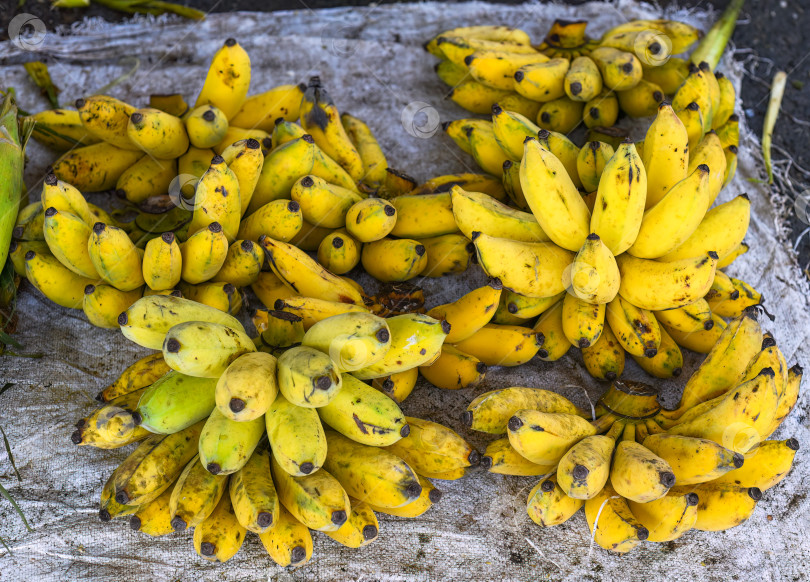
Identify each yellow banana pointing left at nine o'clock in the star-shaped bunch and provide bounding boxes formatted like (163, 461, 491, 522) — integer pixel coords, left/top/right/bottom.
(473, 232, 576, 297)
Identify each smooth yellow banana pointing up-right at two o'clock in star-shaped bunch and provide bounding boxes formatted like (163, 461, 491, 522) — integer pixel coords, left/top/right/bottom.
(627, 164, 715, 261)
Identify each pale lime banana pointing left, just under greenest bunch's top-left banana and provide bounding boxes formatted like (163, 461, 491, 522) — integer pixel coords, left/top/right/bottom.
(163, 321, 256, 378)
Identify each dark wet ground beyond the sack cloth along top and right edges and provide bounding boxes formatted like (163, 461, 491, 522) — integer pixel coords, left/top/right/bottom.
(0, 0, 810, 276)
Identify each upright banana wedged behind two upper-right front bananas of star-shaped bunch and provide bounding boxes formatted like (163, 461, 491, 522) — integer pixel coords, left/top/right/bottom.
(641, 103, 690, 208)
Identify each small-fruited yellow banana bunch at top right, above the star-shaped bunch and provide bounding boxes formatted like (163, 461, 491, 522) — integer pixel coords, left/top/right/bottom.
(425, 20, 716, 135)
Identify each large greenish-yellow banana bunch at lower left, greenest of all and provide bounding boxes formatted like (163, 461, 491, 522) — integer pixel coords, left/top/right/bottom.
(72, 295, 479, 566)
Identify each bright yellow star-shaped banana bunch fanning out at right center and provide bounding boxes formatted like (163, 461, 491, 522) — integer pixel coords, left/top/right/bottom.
(436, 67, 744, 380)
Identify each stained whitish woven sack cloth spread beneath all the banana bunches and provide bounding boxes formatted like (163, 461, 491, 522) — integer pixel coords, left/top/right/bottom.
(0, 1, 810, 582)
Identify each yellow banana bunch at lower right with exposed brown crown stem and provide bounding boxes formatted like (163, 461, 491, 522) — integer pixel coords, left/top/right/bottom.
(462, 310, 802, 553)
